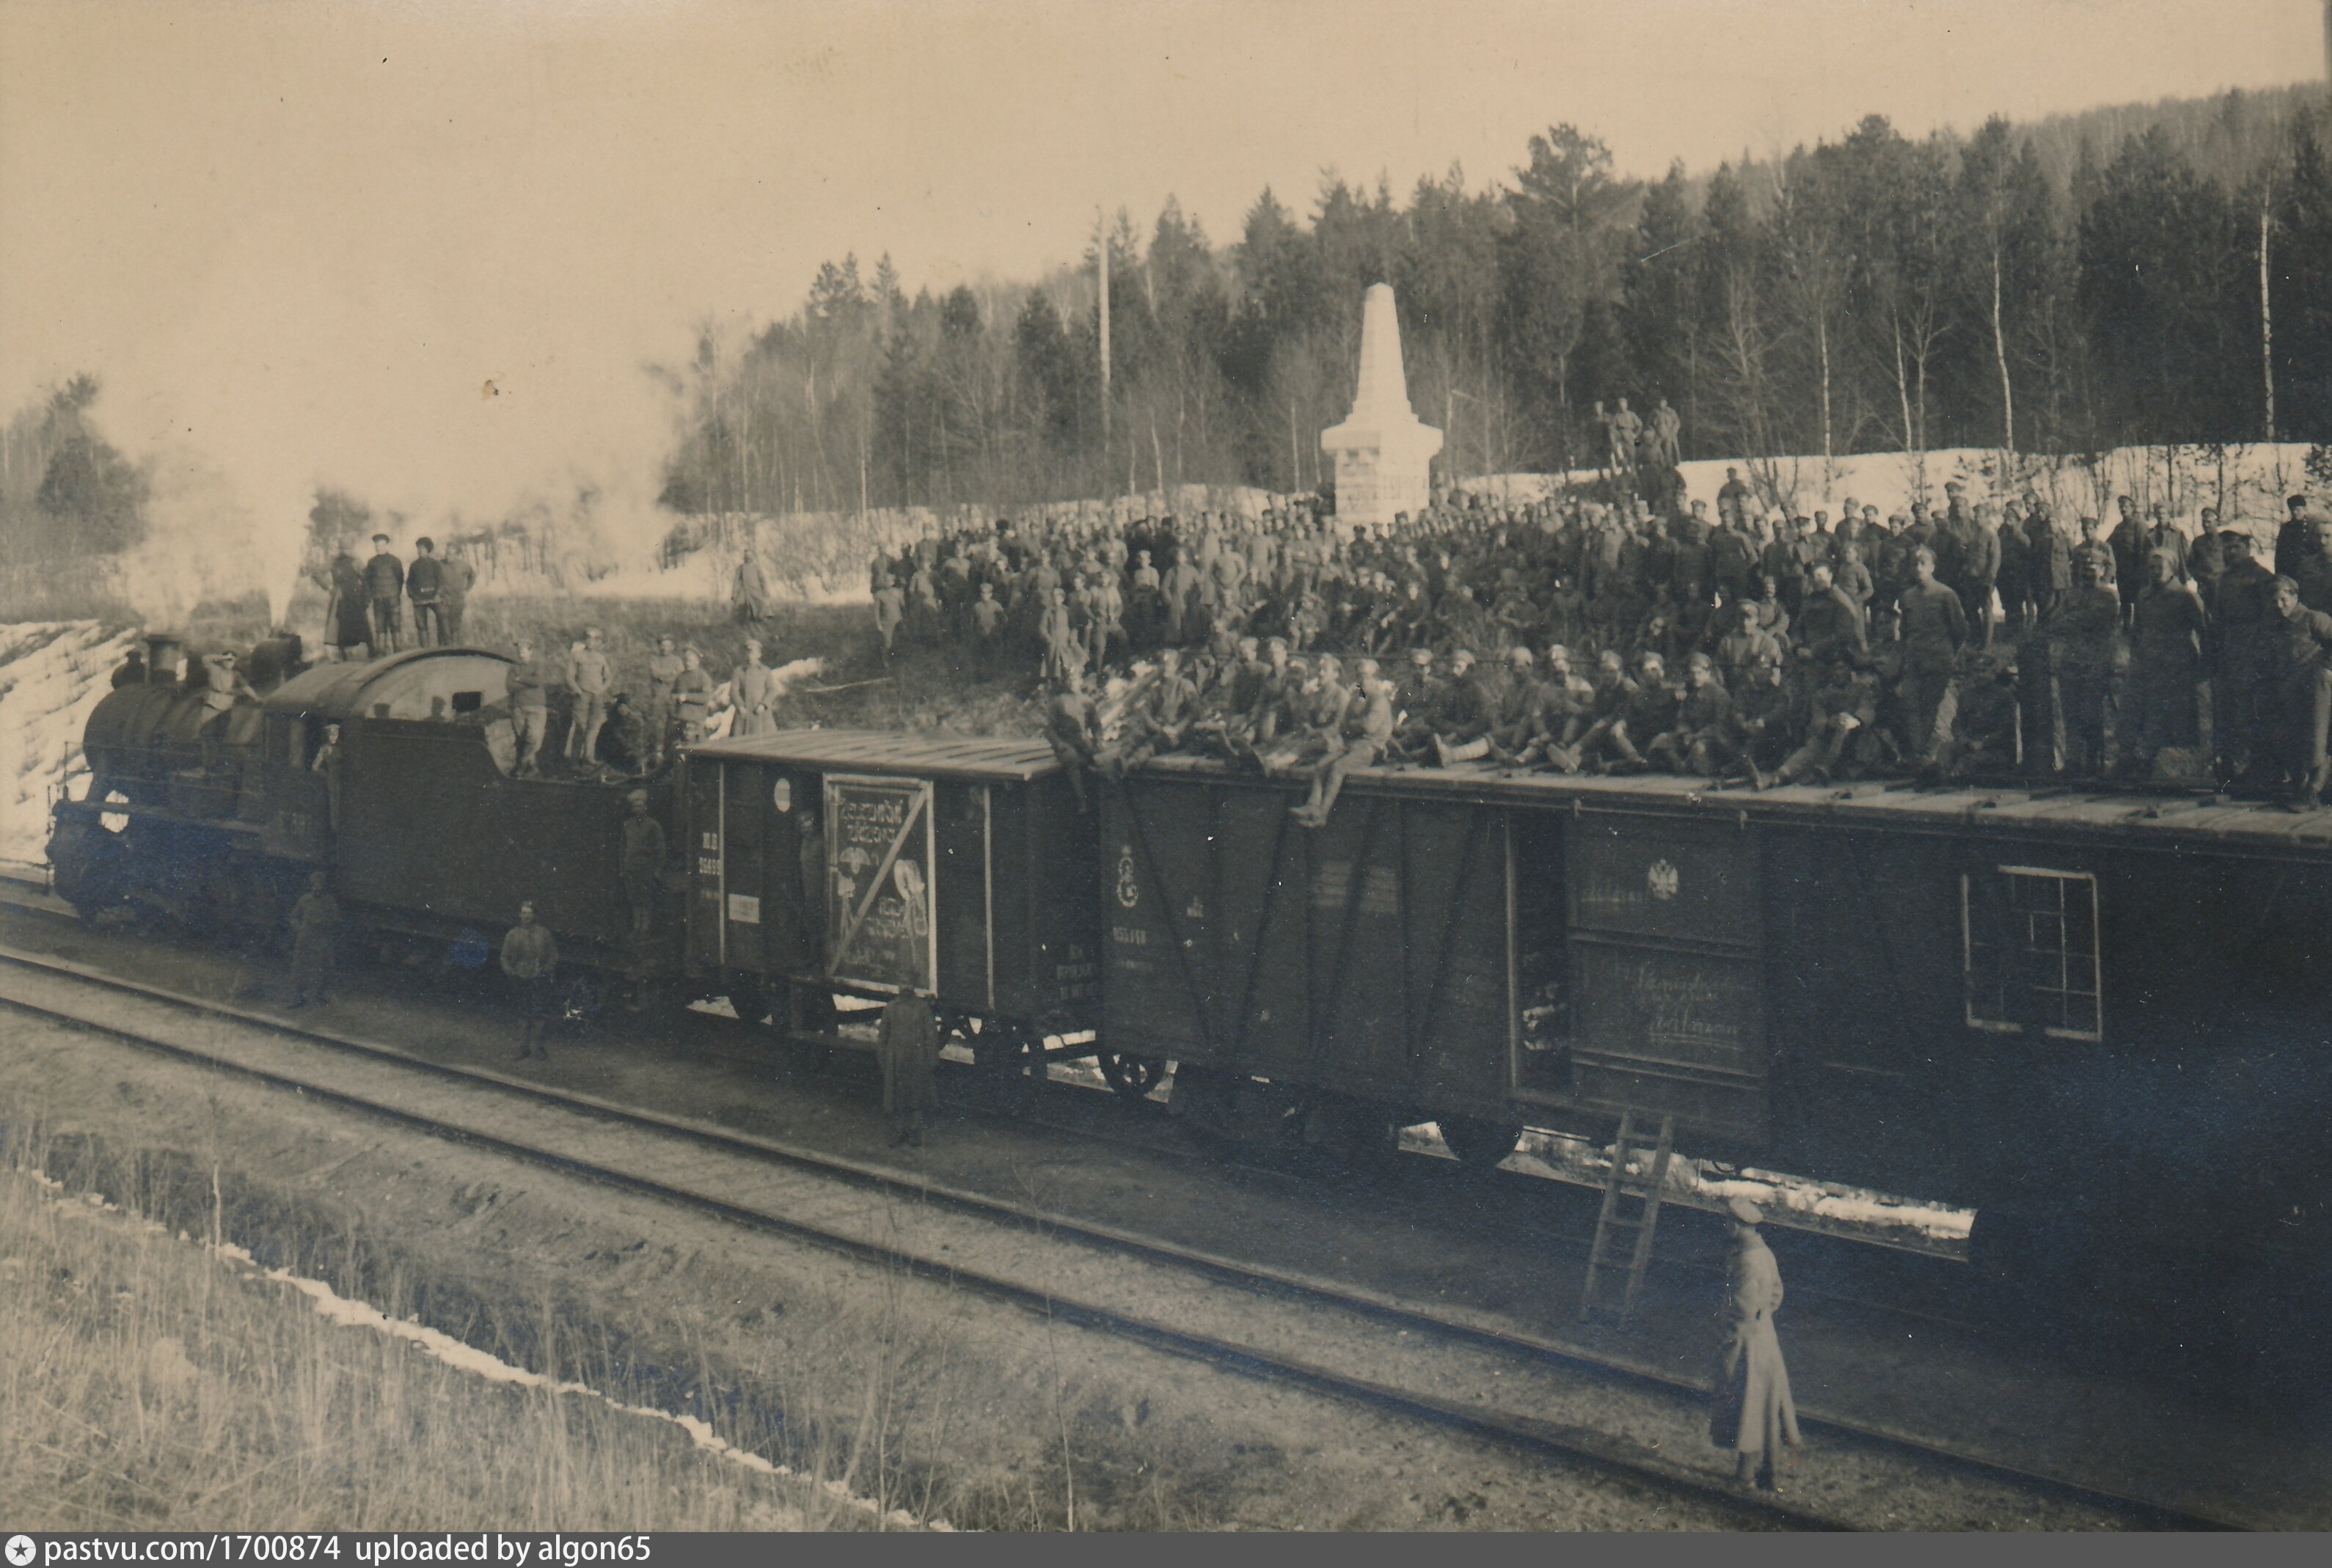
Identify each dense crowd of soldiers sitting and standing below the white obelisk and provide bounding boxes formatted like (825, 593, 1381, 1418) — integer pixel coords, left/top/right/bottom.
(872, 471, 2332, 825)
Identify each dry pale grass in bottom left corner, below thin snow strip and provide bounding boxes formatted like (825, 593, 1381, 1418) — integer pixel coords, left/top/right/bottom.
(0, 1172, 868, 1531)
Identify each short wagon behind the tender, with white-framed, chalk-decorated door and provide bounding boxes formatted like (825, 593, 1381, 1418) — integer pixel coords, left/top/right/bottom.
(688, 729, 1100, 1055)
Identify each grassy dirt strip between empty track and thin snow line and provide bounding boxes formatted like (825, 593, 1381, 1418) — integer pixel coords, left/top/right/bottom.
(0, 1002, 1740, 1528)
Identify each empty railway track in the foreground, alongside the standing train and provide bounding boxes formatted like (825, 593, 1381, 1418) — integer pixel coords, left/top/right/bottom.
(0, 946, 2243, 1531)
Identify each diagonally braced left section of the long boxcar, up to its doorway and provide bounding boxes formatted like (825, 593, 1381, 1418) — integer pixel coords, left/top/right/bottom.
(1100, 757, 1535, 1158)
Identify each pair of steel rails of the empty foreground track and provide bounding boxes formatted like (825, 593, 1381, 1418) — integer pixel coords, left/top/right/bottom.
(0, 946, 2251, 1531)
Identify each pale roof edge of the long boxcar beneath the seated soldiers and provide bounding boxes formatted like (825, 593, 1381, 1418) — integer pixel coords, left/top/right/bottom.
(1147, 757, 2332, 860)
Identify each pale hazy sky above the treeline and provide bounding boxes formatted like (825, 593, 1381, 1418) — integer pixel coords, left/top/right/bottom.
(0, 0, 2325, 559)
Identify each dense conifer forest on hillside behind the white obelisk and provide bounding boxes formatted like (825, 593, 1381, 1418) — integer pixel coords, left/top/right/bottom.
(662, 87, 2332, 513)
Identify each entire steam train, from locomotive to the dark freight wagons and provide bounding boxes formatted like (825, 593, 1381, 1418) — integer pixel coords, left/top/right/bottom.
(51, 648, 2332, 1277)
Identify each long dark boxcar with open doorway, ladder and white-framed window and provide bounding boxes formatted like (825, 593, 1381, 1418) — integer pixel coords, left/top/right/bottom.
(1103, 760, 2332, 1286)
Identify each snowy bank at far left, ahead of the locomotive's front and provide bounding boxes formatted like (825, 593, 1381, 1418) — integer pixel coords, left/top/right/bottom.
(0, 620, 138, 867)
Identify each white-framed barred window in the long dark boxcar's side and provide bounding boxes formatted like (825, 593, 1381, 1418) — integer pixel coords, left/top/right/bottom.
(1959, 867, 2106, 1039)
